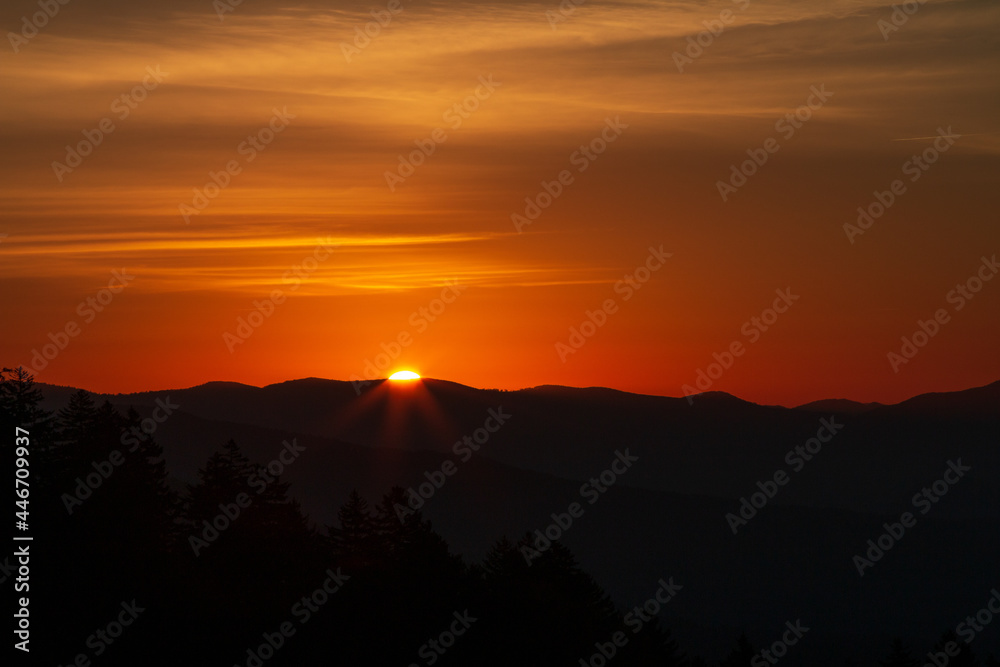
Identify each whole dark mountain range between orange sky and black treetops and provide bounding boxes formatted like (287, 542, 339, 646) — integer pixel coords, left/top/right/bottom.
(33, 378, 1000, 665)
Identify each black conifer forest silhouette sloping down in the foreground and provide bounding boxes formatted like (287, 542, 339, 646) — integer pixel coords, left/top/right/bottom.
(0, 368, 1000, 667)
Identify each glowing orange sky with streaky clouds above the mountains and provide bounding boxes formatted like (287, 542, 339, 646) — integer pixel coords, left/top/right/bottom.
(0, 0, 1000, 405)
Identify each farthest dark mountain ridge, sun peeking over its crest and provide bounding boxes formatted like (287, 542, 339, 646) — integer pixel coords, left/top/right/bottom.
(46, 378, 1000, 516)
